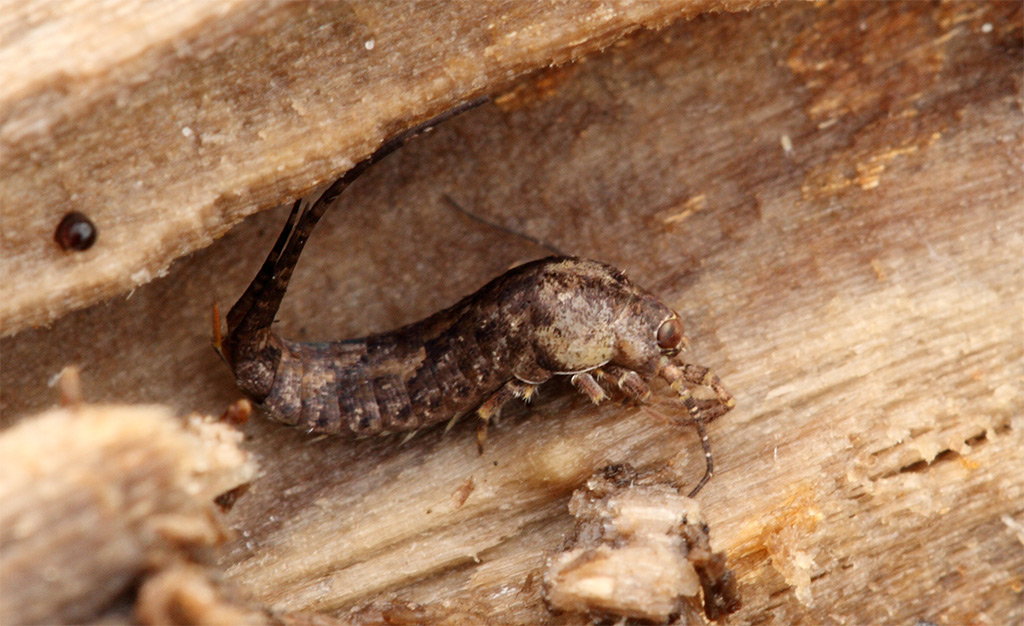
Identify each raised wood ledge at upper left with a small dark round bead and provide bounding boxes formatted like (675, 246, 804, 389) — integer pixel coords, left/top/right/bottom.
(0, 0, 766, 336)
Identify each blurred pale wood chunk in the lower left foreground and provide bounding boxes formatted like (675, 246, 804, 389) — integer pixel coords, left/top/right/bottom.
(0, 406, 255, 624)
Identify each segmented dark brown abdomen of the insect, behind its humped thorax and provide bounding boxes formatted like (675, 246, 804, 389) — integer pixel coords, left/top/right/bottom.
(263, 302, 511, 435)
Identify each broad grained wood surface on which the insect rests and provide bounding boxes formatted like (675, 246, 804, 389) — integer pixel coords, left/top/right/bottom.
(0, 2, 1024, 624)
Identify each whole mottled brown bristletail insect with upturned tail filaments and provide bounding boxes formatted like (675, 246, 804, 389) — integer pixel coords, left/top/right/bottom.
(215, 101, 733, 496)
